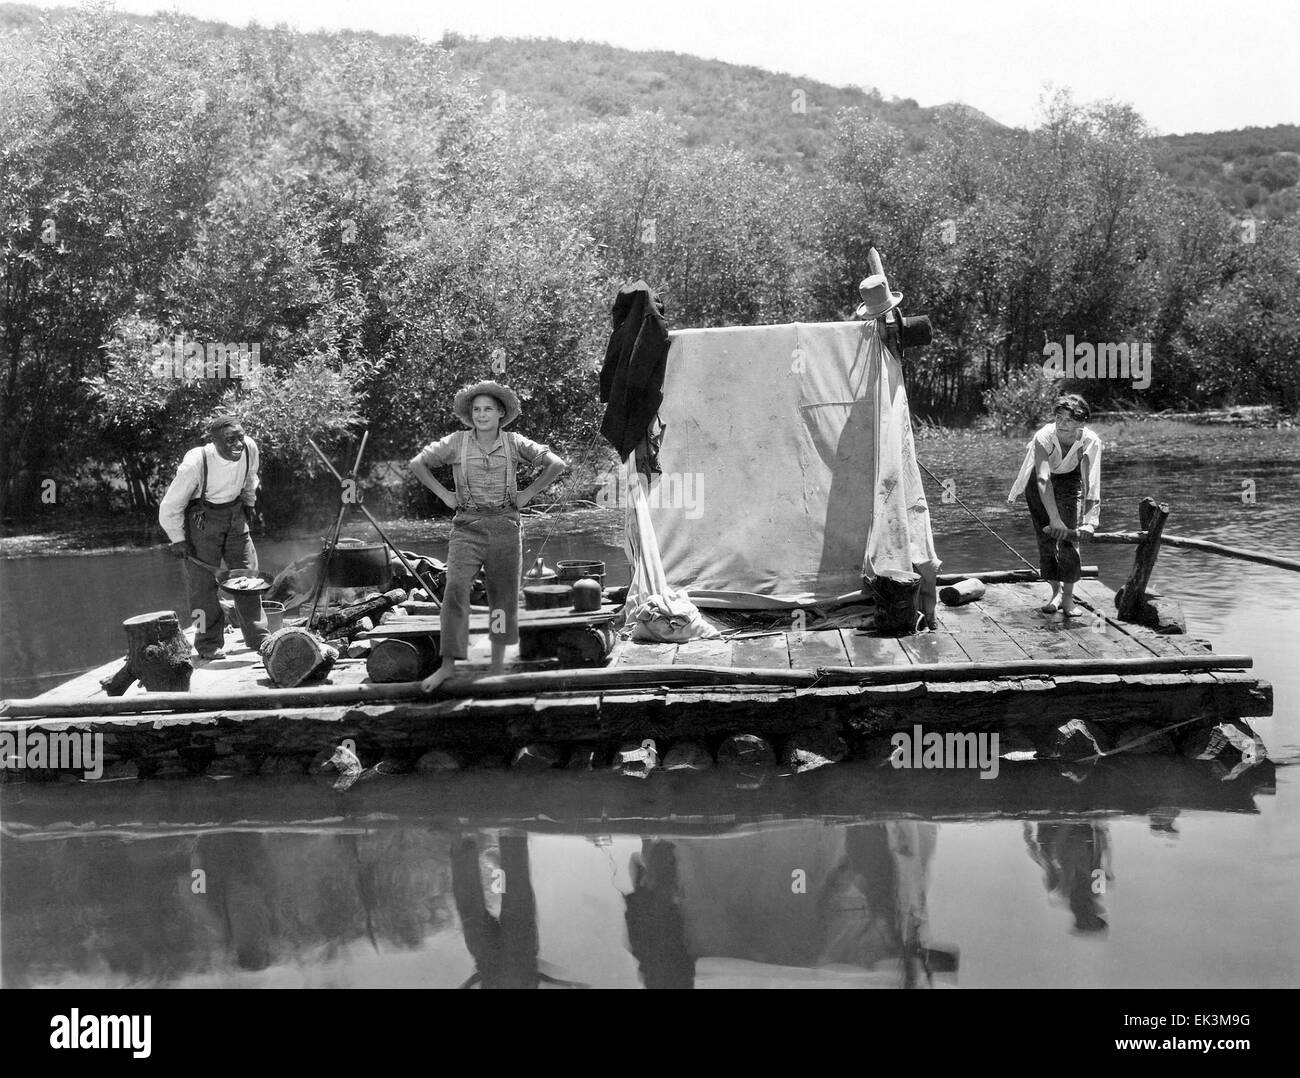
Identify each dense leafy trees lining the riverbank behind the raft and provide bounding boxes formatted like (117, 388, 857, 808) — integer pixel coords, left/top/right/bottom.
(0, 10, 1300, 519)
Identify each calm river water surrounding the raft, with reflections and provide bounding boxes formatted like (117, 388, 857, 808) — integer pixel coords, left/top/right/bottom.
(0, 424, 1300, 987)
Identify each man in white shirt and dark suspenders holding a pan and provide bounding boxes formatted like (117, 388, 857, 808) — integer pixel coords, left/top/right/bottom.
(159, 414, 259, 659)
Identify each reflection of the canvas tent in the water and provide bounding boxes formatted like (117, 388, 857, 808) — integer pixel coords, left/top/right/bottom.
(627, 821, 957, 988)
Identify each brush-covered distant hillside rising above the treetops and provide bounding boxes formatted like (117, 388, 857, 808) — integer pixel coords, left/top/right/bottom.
(0, 4, 1300, 211)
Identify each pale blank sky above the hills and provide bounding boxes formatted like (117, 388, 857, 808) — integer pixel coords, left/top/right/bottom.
(17, 0, 1300, 134)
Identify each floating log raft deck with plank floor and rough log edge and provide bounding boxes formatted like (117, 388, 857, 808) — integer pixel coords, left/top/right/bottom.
(0, 570, 1273, 778)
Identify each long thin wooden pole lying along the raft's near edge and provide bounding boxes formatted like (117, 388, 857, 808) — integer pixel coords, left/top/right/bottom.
(0, 655, 1255, 720)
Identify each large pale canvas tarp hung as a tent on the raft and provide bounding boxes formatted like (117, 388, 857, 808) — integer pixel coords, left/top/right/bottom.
(649, 322, 939, 602)
